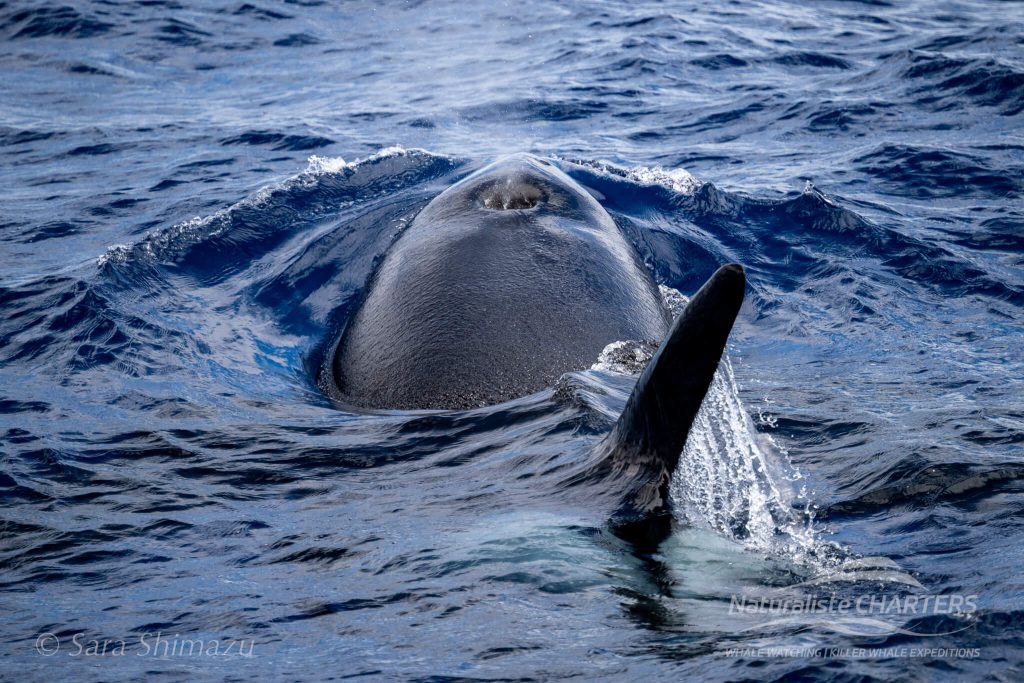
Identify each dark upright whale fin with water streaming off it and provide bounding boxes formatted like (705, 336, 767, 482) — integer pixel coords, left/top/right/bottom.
(590, 263, 745, 538)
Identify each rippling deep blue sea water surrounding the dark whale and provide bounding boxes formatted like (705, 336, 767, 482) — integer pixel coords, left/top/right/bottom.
(0, 0, 1024, 681)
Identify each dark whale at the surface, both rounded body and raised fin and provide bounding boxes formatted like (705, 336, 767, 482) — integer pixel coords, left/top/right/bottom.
(322, 155, 745, 538)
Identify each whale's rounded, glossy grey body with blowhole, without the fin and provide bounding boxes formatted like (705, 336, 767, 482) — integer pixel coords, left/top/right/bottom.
(333, 155, 671, 410)
